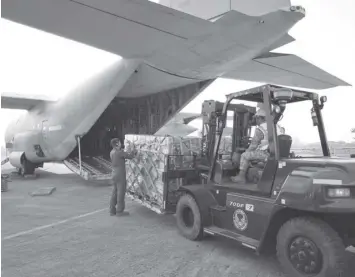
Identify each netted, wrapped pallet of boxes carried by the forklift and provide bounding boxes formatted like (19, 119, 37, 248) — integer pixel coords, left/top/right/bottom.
(125, 135, 201, 213)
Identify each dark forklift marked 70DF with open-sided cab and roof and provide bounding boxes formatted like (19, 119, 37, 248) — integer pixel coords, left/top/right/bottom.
(176, 85, 355, 277)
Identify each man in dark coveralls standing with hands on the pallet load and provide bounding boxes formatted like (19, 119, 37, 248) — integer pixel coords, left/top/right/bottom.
(110, 138, 136, 216)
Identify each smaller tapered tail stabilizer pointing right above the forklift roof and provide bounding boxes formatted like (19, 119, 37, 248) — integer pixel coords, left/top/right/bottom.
(223, 53, 349, 89)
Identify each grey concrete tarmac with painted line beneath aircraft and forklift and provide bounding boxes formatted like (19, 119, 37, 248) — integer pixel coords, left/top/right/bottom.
(1, 165, 355, 277)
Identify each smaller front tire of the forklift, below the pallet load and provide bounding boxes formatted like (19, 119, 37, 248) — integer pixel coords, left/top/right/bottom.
(176, 194, 203, 240)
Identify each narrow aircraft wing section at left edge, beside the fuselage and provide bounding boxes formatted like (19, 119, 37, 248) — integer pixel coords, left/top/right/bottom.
(1, 93, 55, 110)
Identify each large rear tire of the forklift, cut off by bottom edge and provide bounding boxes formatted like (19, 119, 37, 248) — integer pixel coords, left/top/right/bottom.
(276, 217, 346, 277)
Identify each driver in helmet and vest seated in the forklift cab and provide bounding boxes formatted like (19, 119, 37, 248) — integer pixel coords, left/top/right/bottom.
(231, 107, 285, 184)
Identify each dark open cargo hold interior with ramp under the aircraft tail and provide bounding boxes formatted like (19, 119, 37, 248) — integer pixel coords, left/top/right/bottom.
(66, 82, 210, 178)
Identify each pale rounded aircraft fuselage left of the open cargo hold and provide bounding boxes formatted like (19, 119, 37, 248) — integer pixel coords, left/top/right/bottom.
(5, 59, 138, 163)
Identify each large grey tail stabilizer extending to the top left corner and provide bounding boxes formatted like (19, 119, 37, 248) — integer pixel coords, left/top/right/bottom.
(2, 0, 216, 59)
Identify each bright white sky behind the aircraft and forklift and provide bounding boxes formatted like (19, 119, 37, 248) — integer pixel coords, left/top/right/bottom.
(0, 0, 355, 145)
